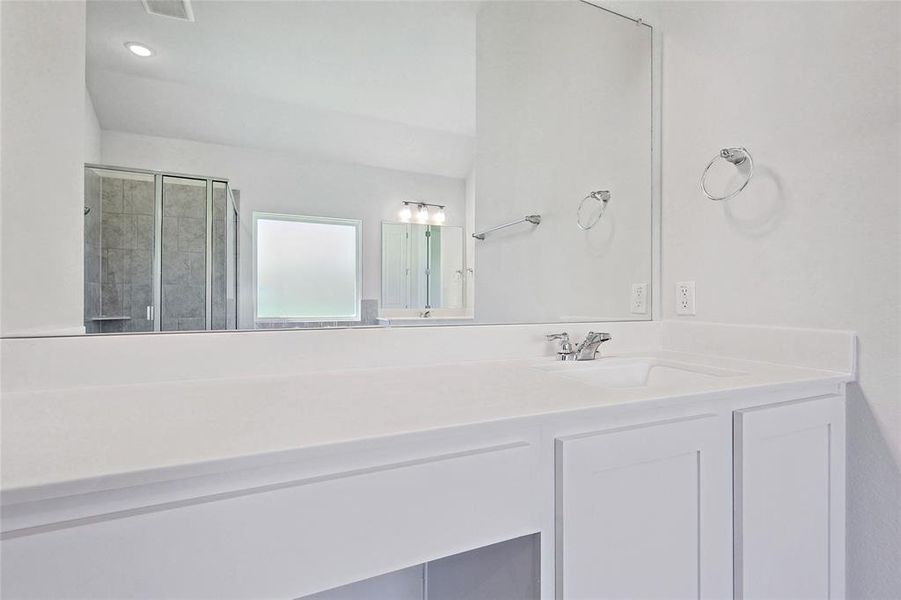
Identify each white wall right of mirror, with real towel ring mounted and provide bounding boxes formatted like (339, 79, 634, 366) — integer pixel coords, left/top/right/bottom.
(658, 2, 901, 598)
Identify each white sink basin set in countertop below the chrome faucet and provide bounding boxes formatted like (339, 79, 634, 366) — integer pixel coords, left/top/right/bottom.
(539, 358, 744, 388)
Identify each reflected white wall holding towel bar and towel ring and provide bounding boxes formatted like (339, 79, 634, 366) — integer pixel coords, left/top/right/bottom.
(475, 2, 653, 322)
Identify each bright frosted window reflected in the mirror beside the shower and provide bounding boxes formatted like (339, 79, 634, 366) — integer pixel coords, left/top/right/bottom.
(254, 214, 361, 321)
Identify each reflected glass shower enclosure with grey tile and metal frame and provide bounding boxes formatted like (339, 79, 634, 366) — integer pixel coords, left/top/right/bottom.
(84, 165, 238, 333)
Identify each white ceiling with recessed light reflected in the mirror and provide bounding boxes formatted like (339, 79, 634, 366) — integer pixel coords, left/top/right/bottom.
(87, 0, 478, 177)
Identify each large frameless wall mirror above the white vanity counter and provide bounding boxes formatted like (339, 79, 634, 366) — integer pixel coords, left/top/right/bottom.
(7, 0, 655, 335)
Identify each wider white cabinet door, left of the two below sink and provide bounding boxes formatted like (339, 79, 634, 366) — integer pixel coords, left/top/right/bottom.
(556, 415, 732, 600)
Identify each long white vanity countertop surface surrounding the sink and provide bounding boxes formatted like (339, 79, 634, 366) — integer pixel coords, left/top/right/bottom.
(0, 352, 852, 492)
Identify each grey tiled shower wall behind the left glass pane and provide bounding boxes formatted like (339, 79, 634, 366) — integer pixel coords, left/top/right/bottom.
(101, 177, 154, 333)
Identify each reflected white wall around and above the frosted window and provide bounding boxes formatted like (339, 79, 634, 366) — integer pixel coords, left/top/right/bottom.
(102, 131, 465, 328)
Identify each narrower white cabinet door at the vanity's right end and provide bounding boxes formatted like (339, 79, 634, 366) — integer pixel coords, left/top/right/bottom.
(734, 396, 845, 600)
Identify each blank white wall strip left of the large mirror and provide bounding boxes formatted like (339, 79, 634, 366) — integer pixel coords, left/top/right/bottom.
(0, 1, 85, 336)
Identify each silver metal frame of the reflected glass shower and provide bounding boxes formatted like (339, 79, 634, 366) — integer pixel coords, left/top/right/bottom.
(84, 163, 241, 333)
